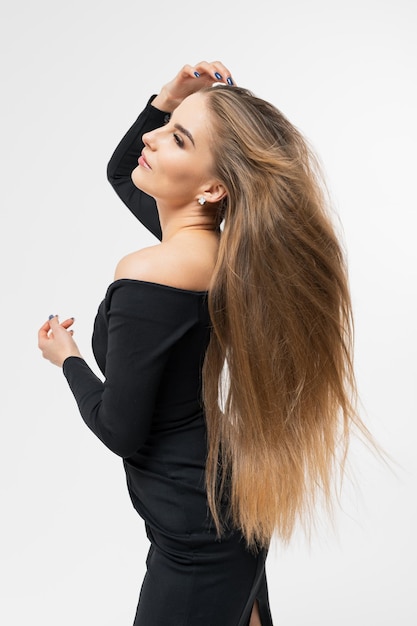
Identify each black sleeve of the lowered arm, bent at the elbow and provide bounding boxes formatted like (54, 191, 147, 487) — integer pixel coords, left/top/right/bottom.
(63, 279, 198, 457)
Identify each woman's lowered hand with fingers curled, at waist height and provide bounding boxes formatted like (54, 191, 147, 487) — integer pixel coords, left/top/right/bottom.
(38, 315, 82, 367)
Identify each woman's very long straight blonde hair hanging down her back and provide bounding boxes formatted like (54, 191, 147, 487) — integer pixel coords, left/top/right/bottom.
(203, 87, 366, 547)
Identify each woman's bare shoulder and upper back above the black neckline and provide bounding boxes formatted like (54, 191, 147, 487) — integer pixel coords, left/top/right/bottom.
(114, 235, 217, 291)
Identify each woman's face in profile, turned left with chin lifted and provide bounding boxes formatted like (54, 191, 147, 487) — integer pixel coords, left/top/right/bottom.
(132, 93, 219, 207)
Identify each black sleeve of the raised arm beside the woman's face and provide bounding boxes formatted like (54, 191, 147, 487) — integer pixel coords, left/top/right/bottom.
(107, 96, 168, 239)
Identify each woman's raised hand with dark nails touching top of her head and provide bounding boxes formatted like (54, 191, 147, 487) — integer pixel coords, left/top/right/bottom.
(152, 61, 234, 113)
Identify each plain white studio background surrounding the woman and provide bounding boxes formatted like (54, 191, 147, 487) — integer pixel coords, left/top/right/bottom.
(0, 0, 417, 626)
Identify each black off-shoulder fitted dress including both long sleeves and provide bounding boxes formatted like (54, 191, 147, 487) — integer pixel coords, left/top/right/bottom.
(63, 95, 272, 626)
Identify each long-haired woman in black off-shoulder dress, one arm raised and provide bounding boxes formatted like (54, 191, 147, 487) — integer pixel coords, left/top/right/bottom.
(39, 62, 361, 626)
